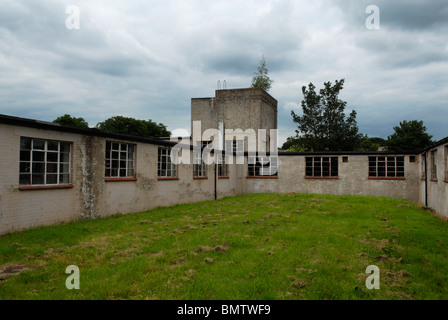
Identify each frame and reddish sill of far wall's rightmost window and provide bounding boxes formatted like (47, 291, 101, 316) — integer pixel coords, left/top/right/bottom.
(368, 155, 406, 180)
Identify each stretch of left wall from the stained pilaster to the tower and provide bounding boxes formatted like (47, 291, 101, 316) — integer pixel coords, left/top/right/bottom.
(96, 144, 236, 216)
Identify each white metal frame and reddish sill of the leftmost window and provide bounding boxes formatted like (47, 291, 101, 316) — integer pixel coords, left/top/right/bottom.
(19, 137, 73, 186)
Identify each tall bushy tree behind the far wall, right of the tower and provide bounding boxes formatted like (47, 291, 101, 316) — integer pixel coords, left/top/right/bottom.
(291, 79, 362, 151)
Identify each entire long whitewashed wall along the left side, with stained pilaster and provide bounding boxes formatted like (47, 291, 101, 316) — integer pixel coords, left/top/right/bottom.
(0, 124, 237, 234)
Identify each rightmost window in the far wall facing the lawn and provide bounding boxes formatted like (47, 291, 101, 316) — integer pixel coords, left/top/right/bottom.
(369, 156, 404, 178)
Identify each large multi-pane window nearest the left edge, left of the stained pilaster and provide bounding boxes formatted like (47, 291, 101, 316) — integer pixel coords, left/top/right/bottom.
(19, 137, 71, 185)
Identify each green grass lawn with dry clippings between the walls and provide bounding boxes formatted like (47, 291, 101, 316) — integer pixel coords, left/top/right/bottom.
(0, 194, 448, 300)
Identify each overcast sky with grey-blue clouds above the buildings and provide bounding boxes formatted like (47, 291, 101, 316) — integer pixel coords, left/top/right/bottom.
(0, 0, 448, 145)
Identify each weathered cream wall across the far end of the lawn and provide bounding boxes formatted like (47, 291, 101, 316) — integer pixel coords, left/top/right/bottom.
(245, 155, 420, 202)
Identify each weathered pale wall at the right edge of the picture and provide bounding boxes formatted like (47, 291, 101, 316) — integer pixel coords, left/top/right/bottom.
(419, 143, 448, 217)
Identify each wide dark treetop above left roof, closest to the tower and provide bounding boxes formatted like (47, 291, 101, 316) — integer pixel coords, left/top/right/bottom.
(96, 116, 171, 138)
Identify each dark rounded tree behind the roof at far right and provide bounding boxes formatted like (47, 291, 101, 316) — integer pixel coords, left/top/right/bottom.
(386, 120, 433, 150)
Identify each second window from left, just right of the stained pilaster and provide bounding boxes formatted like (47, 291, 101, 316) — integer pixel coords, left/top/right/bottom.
(105, 141, 135, 178)
